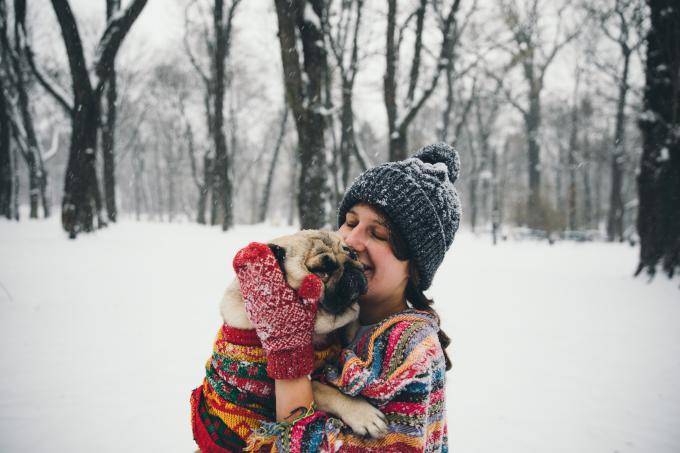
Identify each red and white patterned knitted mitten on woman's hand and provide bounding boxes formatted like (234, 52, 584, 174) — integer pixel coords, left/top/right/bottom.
(234, 242, 323, 379)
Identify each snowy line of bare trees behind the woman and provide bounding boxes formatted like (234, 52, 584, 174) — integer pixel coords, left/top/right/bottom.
(0, 0, 680, 274)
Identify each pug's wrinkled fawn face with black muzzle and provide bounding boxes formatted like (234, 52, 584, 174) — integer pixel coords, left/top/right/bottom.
(268, 230, 368, 316)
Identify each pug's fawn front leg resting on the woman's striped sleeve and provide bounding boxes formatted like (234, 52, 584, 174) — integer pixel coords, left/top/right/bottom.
(312, 381, 387, 437)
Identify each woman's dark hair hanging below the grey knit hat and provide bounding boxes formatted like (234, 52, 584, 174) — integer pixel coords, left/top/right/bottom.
(371, 206, 451, 371)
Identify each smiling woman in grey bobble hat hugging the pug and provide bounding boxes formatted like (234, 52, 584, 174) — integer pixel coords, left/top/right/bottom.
(234, 144, 461, 452)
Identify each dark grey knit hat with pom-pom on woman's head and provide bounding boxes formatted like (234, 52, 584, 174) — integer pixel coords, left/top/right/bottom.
(338, 143, 461, 290)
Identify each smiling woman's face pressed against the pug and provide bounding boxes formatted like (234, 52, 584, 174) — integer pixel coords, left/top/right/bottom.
(338, 204, 408, 303)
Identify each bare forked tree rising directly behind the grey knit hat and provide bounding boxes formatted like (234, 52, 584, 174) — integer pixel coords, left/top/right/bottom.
(383, 0, 460, 160)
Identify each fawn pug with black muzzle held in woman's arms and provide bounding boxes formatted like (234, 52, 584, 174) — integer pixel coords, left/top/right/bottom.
(220, 230, 387, 437)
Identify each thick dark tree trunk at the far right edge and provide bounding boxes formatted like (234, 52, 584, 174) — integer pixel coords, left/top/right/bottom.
(635, 0, 680, 277)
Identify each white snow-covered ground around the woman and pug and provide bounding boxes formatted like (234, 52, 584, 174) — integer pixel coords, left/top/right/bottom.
(0, 218, 680, 453)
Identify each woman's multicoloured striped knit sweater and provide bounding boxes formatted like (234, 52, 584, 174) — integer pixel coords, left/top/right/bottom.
(250, 309, 448, 452)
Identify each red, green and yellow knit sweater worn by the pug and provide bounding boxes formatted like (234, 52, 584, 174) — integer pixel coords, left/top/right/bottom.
(191, 324, 339, 453)
